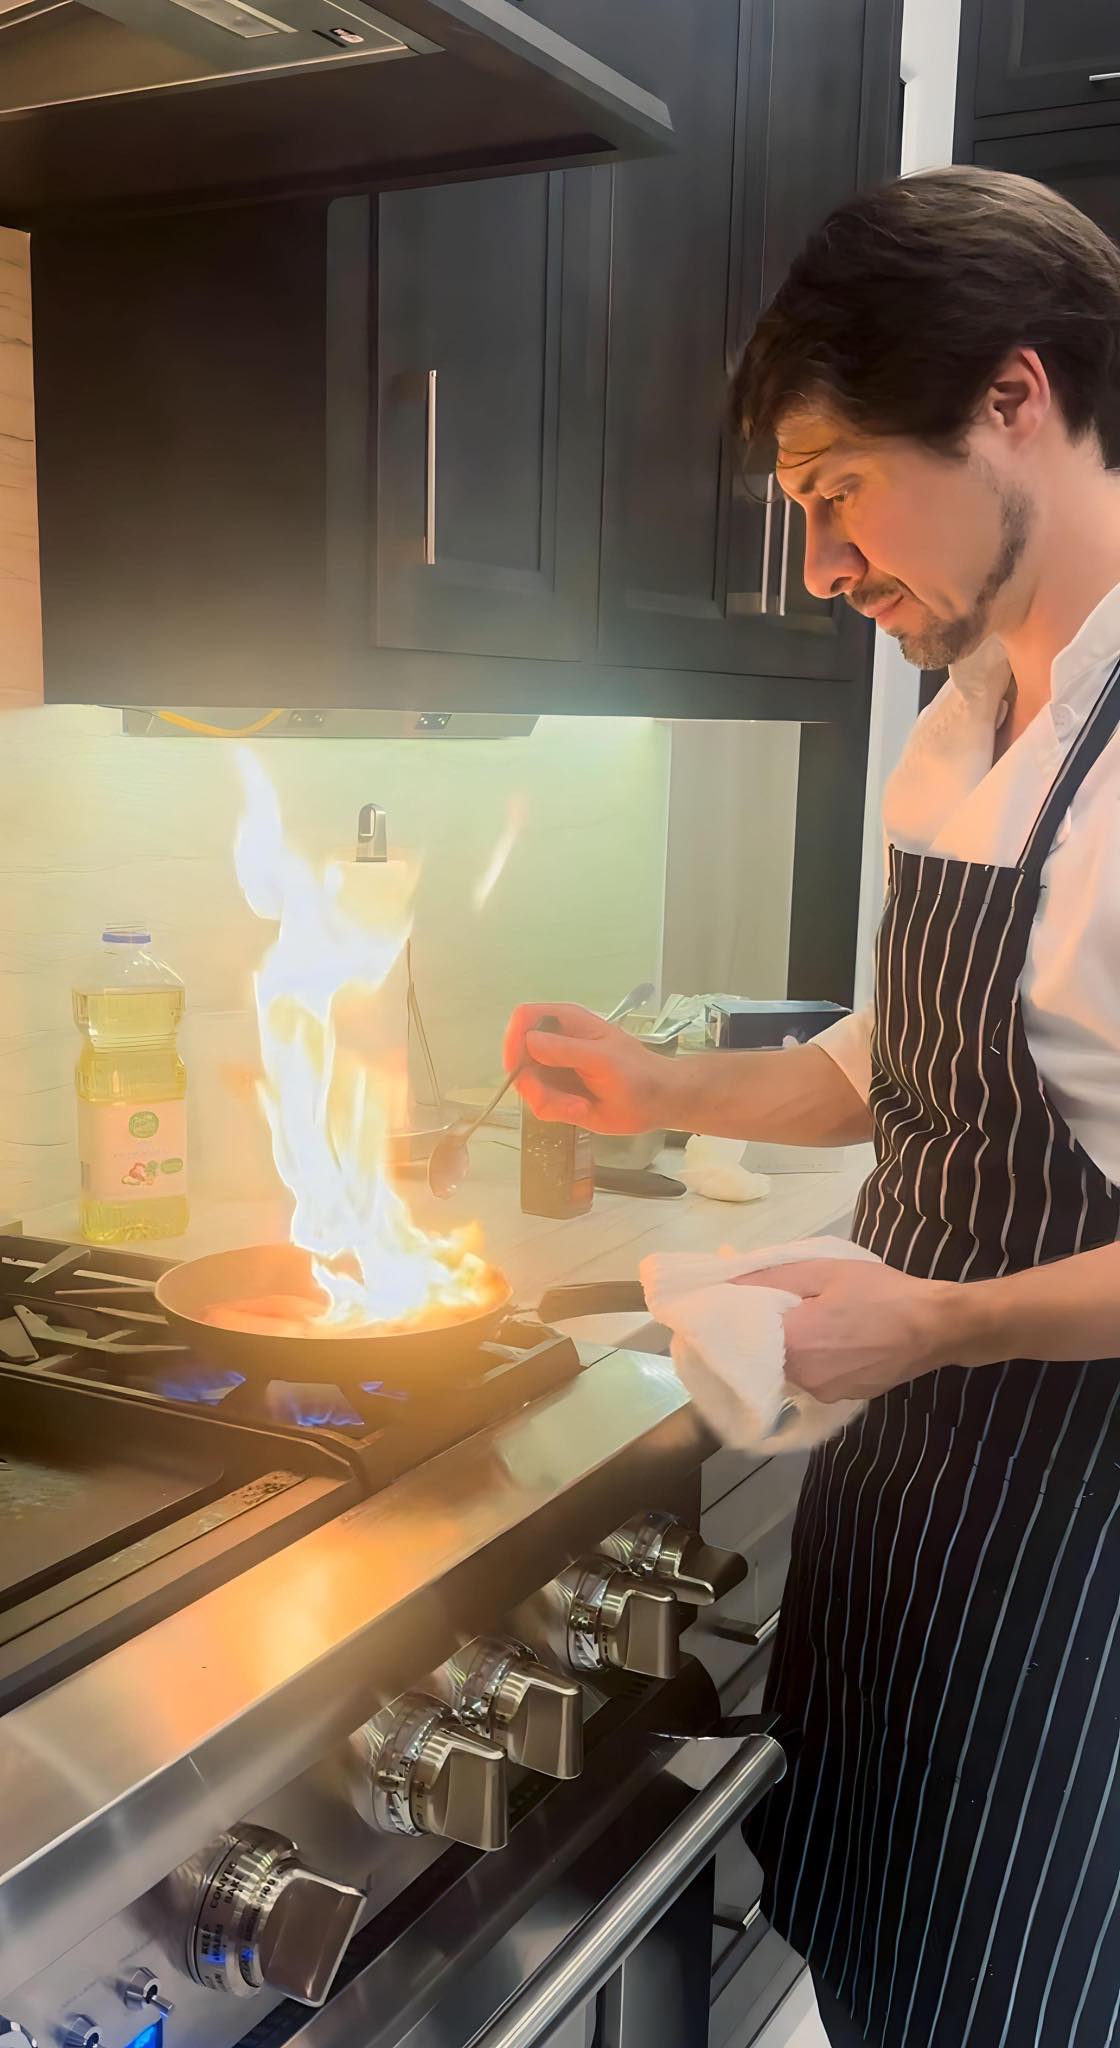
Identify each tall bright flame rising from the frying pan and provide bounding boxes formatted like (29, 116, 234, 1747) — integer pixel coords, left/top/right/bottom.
(235, 750, 504, 1335)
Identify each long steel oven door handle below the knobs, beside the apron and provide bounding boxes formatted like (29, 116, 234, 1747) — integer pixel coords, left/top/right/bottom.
(471, 1735, 786, 2048)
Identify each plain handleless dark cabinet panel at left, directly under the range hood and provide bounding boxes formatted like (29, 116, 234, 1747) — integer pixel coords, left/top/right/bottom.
(34, 201, 328, 707)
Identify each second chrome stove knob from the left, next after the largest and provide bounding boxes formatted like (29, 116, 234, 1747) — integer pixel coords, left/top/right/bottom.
(354, 1694, 510, 1849)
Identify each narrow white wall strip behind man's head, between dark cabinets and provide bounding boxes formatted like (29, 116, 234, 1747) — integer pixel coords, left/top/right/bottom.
(856, 0, 960, 1004)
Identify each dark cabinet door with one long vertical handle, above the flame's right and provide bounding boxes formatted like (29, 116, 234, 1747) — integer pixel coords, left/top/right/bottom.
(373, 170, 608, 662)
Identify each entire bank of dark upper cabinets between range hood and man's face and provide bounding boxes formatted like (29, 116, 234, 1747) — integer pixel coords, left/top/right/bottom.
(33, 0, 901, 731)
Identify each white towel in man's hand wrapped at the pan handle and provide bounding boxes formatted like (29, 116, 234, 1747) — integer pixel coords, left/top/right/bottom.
(641, 1237, 878, 1452)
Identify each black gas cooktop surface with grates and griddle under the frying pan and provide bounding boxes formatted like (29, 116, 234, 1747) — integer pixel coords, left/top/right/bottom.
(0, 1237, 598, 1708)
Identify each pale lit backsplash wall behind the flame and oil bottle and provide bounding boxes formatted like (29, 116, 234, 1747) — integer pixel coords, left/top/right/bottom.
(0, 707, 670, 1214)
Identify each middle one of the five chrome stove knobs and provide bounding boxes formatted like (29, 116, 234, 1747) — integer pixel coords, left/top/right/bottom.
(450, 1642, 584, 1778)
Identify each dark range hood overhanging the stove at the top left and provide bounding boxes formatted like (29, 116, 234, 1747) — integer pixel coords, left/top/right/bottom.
(0, 0, 671, 227)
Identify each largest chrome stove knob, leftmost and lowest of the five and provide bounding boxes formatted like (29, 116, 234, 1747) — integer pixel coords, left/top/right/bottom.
(186, 1827, 364, 2005)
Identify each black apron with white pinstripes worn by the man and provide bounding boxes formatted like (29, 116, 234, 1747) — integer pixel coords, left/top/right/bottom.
(751, 668, 1120, 2048)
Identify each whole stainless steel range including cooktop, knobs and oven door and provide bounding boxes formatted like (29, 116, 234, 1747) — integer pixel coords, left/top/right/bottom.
(0, 1237, 782, 2048)
